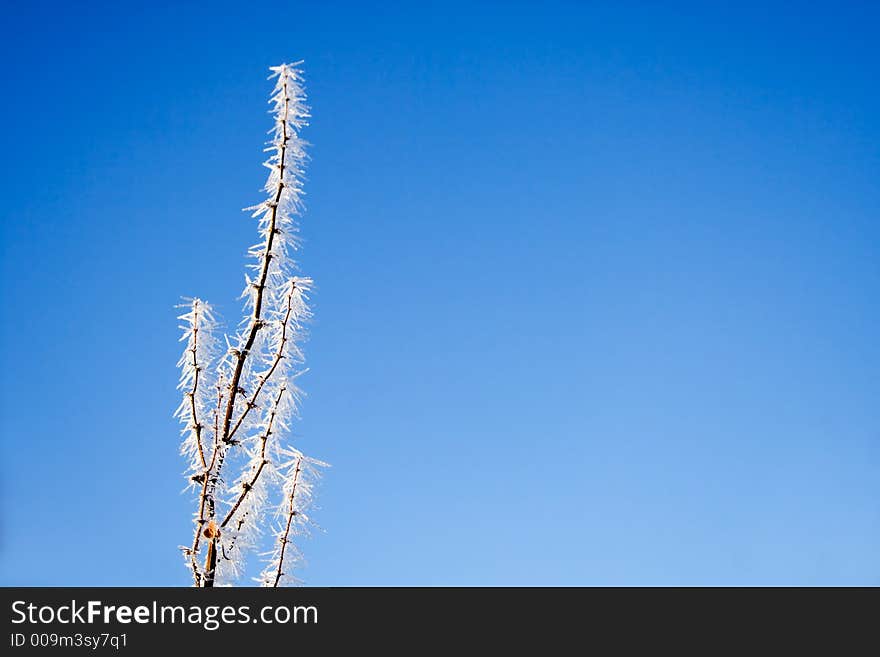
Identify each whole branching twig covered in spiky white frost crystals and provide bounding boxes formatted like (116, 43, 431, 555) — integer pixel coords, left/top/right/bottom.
(176, 64, 326, 586)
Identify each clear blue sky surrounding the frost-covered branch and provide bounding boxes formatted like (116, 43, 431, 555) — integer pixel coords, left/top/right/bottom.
(0, 0, 880, 585)
